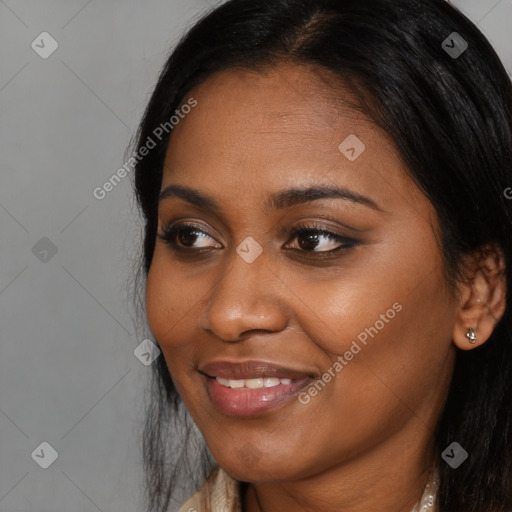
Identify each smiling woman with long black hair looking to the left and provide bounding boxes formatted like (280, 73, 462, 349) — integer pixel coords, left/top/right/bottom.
(131, 0, 512, 512)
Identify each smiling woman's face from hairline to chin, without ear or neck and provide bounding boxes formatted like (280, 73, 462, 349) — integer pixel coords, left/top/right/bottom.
(146, 65, 457, 481)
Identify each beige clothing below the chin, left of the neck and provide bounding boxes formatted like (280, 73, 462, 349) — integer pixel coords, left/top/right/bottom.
(178, 467, 242, 512)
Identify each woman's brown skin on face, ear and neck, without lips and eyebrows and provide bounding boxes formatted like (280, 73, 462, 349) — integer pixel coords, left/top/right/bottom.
(146, 64, 505, 512)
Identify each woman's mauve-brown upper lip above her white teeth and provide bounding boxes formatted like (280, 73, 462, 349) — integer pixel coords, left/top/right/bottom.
(199, 360, 312, 380)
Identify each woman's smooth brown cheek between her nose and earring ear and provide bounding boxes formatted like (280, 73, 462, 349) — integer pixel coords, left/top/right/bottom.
(300, 232, 456, 412)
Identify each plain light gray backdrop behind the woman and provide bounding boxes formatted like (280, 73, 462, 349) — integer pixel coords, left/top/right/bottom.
(0, 0, 512, 512)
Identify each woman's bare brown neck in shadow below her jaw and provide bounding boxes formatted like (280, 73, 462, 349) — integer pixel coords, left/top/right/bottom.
(242, 424, 435, 512)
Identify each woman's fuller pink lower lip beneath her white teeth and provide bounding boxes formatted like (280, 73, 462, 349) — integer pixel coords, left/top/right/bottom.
(204, 376, 312, 417)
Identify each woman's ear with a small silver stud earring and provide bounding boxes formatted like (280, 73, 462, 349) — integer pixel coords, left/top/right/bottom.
(452, 244, 507, 350)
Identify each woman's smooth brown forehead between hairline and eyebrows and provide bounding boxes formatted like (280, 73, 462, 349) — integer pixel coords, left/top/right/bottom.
(162, 65, 424, 216)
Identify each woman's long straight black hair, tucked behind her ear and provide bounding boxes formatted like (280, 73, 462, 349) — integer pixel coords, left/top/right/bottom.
(130, 0, 512, 512)
